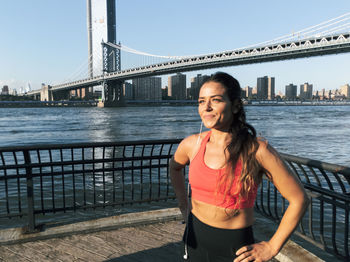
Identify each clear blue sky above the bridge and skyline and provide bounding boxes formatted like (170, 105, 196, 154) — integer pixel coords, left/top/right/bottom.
(0, 0, 350, 92)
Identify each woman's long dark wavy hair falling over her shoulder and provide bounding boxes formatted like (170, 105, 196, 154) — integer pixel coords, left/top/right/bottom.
(203, 72, 264, 206)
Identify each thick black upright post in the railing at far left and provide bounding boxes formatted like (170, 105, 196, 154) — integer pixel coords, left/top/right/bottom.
(23, 150, 35, 233)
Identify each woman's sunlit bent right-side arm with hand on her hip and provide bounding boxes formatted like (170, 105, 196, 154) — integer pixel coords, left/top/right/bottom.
(234, 141, 309, 262)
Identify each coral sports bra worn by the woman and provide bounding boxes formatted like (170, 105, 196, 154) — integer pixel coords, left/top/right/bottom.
(189, 131, 258, 209)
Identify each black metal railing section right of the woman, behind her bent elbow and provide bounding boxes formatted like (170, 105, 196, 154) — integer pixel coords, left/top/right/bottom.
(255, 154, 350, 261)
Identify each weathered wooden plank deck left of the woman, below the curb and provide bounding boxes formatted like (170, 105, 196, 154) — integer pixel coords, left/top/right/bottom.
(0, 221, 184, 262)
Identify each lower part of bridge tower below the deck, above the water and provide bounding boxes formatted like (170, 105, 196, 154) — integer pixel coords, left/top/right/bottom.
(97, 81, 125, 107)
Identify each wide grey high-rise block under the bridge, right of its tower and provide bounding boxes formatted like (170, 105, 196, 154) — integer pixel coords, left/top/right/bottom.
(132, 77, 162, 100)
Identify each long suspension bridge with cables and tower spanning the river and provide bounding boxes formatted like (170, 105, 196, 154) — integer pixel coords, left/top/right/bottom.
(27, 13, 350, 105)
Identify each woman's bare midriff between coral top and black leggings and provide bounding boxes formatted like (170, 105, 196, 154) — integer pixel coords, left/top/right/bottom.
(191, 199, 254, 229)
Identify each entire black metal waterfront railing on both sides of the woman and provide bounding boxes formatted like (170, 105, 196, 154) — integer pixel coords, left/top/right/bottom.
(0, 139, 350, 261)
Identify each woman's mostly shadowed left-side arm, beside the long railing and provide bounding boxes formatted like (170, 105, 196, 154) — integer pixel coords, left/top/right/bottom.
(169, 137, 192, 222)
